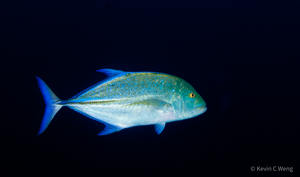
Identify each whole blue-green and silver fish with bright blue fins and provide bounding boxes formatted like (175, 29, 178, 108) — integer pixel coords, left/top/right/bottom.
(36, 69, 207, 135)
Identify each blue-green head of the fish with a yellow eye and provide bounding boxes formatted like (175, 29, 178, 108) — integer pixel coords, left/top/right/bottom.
(172, 80, 207, 120)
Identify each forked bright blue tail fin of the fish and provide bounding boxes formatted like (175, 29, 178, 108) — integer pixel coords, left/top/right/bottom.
(36, 77, 63, 135)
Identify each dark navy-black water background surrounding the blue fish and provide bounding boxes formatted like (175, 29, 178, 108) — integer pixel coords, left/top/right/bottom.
(0, 0, 300, 176)
